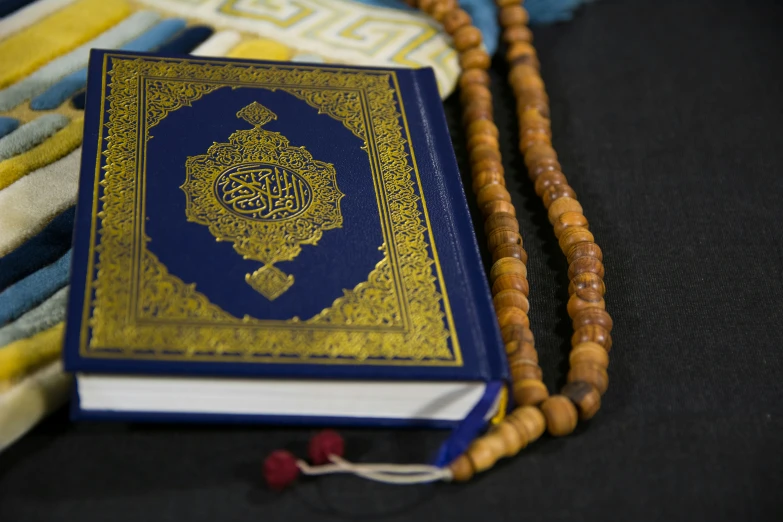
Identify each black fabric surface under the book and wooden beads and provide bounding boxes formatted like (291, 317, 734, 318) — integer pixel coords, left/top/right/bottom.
(0, 0, 783, 522)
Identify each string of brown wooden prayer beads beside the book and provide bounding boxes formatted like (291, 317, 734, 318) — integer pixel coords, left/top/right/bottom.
(408, 0, 612, 481)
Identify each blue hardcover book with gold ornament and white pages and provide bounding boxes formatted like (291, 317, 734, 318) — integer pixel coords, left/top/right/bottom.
(64, 50, 508, 426)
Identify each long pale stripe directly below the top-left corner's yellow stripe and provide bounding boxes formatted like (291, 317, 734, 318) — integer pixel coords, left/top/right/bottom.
(0, 11, 160, 111)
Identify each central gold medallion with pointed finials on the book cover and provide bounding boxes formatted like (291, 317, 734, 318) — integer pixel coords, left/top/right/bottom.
(180, 102, 344, 300)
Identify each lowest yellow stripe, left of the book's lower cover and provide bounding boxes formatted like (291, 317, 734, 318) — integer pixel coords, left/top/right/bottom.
(0, 323, 65, 382)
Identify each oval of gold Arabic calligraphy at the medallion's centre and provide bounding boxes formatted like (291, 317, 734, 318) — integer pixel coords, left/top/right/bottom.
(215, 163, 312, 221)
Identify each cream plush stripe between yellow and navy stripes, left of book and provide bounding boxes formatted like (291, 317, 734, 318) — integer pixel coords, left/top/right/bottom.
(0, 147, 82, 256)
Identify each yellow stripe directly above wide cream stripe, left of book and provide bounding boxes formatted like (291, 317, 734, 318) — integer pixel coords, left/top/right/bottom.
(0, 117, 84, 190)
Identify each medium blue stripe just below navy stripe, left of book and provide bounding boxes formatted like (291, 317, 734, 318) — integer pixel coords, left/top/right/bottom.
(0, 250, 71, 325)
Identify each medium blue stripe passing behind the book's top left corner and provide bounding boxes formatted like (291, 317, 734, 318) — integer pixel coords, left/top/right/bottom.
(36, 18, 187, 111)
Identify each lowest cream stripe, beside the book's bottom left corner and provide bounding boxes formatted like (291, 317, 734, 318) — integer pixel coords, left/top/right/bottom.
(0, 361, 71, 453)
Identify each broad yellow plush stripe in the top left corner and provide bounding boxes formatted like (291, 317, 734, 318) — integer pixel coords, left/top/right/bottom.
(0, 0, 131, 88)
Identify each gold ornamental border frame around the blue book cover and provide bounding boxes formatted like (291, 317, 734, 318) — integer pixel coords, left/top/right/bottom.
(81, 54, 462, 366)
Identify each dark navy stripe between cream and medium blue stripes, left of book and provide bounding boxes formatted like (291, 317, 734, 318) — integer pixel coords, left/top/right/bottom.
(0, 207, 76, 292)
